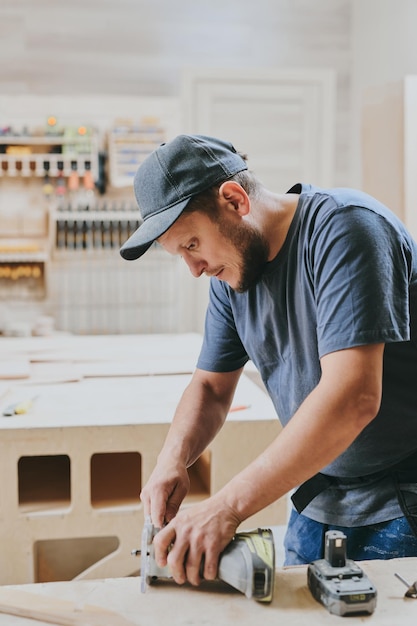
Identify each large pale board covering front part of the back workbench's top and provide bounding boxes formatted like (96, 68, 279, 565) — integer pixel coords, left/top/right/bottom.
(0, 374, 277, 429)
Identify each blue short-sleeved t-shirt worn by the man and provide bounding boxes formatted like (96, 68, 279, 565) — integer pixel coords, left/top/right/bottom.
(198, 184, 417, 526)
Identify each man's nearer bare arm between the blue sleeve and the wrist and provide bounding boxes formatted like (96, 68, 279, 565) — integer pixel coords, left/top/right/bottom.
(217, 347, 380, 521)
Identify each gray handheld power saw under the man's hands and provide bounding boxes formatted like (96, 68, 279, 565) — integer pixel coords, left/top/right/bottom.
(132, 518, 275, 603)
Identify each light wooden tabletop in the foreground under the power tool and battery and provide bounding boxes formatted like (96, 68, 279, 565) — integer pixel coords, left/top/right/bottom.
(0, 558, 417, 626)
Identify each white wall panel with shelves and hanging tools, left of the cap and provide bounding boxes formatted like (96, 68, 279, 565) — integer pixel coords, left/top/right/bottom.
(0, 96, 192, 336)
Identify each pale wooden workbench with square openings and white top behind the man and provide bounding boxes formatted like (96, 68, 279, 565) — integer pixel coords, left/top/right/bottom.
(0, 334, 286, 584)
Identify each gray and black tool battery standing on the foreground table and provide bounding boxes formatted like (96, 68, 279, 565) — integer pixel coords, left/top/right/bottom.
(307, 530, 376, 615)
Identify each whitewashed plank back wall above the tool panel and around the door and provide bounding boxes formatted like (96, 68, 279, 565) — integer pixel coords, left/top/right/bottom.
(0, 0, 352, 184)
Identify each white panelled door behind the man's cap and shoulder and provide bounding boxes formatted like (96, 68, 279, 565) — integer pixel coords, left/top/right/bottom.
(183, 68, 336, 329)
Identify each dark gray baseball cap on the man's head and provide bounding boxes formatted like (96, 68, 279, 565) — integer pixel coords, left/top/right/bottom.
(120, 135, 247, 261)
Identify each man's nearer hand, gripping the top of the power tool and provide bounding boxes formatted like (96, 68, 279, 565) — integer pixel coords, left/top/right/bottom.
(153, 496, 240, 585)
